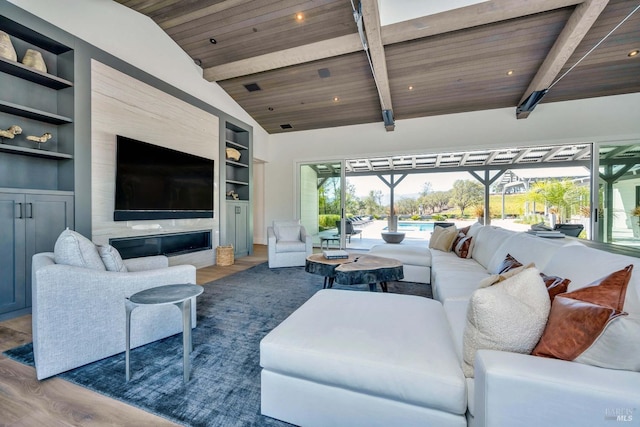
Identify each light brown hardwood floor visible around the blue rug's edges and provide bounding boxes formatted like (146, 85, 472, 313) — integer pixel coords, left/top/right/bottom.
(0, 245, 267, 427)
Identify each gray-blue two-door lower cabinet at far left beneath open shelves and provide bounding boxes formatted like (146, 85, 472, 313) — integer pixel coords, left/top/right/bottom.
(0, 190, 74, 319)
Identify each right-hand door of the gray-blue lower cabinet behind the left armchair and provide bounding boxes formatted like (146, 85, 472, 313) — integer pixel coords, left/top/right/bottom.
(25, 194, 74, 306)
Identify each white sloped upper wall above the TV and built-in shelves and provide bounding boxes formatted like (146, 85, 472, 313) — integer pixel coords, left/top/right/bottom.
(8, 0, 269, 159)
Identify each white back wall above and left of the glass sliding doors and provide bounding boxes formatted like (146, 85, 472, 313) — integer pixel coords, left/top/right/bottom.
(265, 93, 640, 224)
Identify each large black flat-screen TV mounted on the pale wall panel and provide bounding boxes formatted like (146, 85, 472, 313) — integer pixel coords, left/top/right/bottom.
(113, 135, 213, 221)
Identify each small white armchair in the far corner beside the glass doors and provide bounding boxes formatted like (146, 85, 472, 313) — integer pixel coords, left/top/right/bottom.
(267, 220, 313, 268)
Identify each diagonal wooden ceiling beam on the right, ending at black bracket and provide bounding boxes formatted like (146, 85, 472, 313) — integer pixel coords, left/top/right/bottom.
(516, 0, 609, 119)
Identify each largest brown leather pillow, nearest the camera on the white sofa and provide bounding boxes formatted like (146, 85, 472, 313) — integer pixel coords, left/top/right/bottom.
(531, 265, 633, 360)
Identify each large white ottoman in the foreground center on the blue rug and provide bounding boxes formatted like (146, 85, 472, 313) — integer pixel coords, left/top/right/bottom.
(260, 289, 467, 427)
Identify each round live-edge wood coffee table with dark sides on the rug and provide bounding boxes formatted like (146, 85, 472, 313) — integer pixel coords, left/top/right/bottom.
(305, 254, 404, 292)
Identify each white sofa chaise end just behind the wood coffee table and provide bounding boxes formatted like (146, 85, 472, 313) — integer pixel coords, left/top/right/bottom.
(369, 244, 431, 284)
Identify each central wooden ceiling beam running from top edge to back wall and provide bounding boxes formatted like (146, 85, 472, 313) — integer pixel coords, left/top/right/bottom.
(361, 0, 395, 131)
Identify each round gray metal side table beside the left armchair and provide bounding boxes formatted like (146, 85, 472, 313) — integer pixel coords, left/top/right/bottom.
(125, 284, 203, 383)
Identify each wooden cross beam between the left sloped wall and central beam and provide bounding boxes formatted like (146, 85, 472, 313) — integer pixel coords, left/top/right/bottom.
(203, 34, 362, 82)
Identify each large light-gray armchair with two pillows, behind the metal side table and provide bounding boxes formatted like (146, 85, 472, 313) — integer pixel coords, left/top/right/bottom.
(32, 230, 196, 381)
